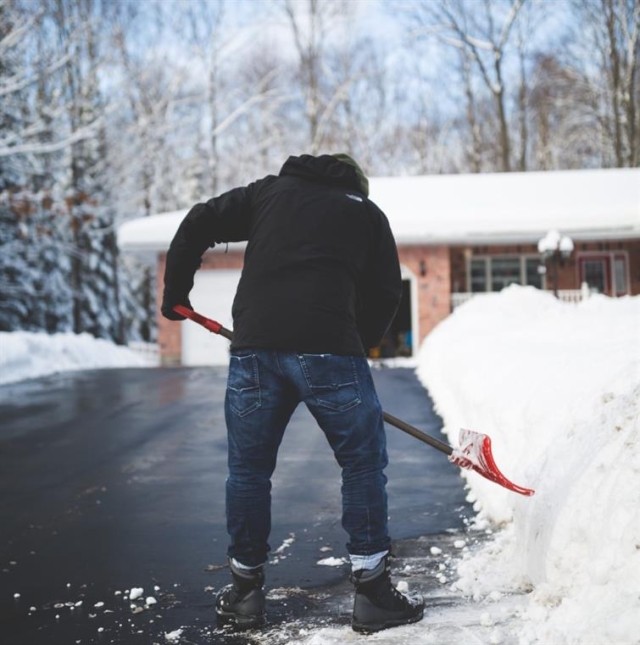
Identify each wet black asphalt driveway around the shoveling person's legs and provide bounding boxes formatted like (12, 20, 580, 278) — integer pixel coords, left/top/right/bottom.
(0, 368, 471, 645)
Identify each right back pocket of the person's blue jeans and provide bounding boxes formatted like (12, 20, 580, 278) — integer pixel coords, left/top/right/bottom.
(298, 354, 361, 412)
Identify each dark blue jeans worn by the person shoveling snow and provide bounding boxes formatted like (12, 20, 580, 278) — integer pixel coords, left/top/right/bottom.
(225, 349, 390, 567)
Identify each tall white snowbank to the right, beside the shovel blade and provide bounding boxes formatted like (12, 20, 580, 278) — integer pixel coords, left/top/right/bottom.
(418, 287, 640, 644)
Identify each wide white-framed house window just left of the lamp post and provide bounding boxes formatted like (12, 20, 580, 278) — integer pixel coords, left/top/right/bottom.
(469, 255, 543, 293)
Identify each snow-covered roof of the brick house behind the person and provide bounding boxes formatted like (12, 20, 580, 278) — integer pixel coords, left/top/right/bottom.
(118, 168, 640, 252)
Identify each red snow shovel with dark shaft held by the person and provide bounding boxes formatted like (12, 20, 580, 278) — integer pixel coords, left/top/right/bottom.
(173, 305, 535, 496)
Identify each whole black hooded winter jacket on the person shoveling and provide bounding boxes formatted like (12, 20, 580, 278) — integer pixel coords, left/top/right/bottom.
(162, 155, 401, 355)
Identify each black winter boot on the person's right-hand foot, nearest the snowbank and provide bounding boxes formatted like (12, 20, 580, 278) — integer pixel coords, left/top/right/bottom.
(351, 556, 424, 634)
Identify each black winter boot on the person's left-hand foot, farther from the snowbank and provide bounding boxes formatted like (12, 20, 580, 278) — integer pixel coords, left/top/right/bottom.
(216, 561, 265, 629)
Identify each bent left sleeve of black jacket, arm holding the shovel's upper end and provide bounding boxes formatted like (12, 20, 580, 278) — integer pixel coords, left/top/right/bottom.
(161, 182, 258, 320)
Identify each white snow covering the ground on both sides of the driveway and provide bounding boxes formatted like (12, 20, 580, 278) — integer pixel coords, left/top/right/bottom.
(0, 287, 640, 645)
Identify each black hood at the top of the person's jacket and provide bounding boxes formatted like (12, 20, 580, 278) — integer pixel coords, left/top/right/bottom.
(280, 155, 369, 197)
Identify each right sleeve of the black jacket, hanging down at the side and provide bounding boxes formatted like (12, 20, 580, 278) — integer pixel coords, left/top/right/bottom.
(358, 203, 402, 350)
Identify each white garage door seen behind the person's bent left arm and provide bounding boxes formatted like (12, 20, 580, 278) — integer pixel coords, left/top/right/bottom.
(182, 269, 240, 365)
